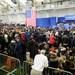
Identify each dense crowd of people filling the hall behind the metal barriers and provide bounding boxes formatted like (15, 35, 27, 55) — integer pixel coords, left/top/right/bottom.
(0, 25, 75, 75)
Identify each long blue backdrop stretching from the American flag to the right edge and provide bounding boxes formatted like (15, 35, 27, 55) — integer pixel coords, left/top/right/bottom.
(36, 15, 75, 28)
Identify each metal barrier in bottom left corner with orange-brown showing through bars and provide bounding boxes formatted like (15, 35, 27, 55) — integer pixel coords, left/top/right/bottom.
(0, 53, 21, 75)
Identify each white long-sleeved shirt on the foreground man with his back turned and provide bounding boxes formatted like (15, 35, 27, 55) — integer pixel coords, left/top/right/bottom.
(32, 54, 48, 72)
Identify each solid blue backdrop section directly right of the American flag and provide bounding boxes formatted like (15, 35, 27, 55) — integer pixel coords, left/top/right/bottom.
(36, 17, 56, 28)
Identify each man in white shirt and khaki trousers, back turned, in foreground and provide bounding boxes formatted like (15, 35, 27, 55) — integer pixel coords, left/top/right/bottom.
(31, 50, 48, 75)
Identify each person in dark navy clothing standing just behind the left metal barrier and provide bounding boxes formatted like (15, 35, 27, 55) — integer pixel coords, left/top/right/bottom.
(14, 35, 25, 63)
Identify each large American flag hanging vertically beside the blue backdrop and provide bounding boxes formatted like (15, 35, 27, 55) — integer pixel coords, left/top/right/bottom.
(26, 9, 36, 27)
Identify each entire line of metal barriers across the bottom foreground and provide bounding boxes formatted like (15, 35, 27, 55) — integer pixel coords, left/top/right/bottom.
(0, 53, 73, 75)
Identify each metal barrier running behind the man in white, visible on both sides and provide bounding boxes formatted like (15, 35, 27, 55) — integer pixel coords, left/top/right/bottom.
(23, 61, 73, 75)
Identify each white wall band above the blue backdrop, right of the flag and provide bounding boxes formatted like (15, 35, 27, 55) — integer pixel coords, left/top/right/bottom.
(37, 8, 75, 18)
